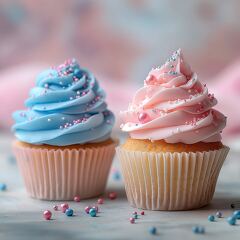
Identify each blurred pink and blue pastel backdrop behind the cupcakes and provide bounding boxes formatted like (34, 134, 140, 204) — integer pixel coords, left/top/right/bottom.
(0, 0, 240, 142)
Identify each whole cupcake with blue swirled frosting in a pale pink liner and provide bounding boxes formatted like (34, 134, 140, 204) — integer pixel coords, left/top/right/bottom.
(13, 59, 115, 200)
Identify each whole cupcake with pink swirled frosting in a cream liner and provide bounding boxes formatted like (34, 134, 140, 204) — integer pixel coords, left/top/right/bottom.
(117, 50, 229, 210)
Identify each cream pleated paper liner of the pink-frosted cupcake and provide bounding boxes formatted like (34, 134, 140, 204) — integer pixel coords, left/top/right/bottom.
(116, 146, 229, 210)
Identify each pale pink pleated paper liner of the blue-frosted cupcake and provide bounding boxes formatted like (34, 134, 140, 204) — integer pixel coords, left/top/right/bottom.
(13, 143, 116, 200)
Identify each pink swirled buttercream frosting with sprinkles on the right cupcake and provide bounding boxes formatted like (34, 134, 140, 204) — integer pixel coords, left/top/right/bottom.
(121, 49, 226, 144)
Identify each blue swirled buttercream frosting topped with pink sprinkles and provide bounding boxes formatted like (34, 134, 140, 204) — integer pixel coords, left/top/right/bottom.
(13, 59, 115, 146)
